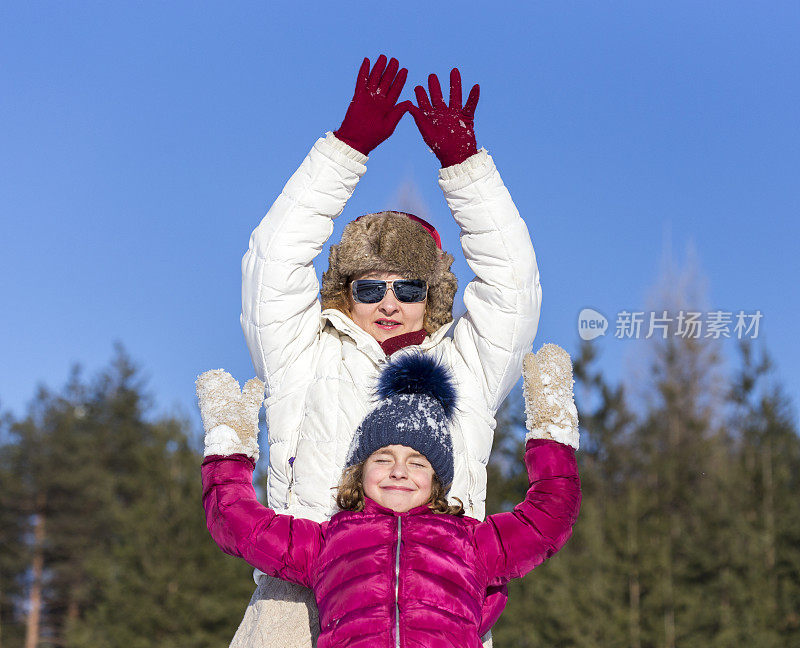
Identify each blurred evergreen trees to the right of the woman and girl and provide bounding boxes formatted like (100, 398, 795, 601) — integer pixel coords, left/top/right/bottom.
(487, 324, 800, 648)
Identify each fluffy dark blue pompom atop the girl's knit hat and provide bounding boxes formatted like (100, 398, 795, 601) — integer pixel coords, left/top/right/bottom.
(377, 353, 456, 418)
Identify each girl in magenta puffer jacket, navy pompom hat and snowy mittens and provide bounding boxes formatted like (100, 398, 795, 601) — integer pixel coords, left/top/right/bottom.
(198, 345, 580, 648)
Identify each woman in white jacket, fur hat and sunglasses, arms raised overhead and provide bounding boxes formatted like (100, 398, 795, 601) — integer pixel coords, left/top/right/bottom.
(231, 56, 541, 648)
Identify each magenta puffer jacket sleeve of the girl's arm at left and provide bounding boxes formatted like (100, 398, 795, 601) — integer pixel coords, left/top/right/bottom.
(202, 454, 322, 587)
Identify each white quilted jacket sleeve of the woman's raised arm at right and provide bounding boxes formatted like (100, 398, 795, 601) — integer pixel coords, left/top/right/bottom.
(439, 149, 542, 412)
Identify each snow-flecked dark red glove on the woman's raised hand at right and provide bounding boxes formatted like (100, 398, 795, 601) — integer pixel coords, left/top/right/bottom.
(408, 68, 481, 168)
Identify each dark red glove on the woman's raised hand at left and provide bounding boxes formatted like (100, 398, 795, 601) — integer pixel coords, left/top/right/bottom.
(333, 54, 413, 155)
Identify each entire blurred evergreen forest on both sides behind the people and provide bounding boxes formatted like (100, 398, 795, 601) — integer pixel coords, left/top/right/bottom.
(0, 338, 800, 648)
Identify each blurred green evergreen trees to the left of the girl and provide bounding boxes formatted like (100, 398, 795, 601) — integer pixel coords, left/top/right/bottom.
(0, 350, 253, 648)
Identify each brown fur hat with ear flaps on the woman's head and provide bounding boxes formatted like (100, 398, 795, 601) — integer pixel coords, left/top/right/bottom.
(321, 211, 458, 335)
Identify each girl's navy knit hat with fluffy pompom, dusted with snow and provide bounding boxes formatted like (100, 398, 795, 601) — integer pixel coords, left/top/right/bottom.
(346, 353, 456, 487)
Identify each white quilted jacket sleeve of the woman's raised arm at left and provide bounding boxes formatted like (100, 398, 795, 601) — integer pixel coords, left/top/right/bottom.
(241, 133, 367, 393)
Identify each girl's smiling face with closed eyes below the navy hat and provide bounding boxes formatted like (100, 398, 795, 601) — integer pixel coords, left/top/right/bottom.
(362, 445, 434, 513)
